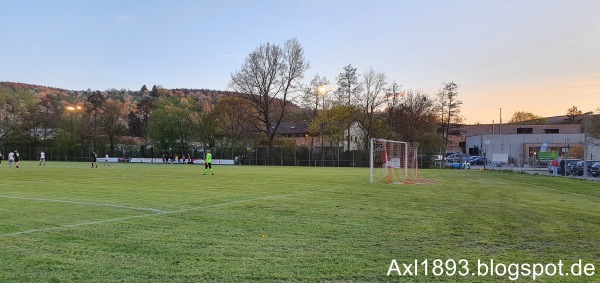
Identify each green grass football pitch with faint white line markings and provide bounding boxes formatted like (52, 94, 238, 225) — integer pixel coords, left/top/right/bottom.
(0, 162, 600, 282)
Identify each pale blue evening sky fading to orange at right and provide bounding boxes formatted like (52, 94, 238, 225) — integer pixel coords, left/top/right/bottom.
(0, 0, 600, 123)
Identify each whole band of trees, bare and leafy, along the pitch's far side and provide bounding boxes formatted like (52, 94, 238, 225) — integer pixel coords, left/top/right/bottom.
(0, 39, 474, 166)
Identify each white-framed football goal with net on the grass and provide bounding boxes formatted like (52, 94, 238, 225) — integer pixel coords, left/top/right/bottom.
(370, 139, 419, 184)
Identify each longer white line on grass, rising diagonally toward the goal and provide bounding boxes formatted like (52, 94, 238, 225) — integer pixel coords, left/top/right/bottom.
(0, 186, 341, 237)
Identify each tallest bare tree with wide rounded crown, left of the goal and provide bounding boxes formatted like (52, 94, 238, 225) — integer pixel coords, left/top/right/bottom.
(229, 38, 309, 165)
